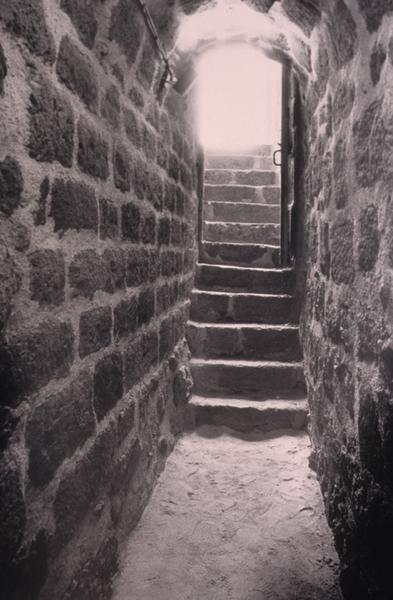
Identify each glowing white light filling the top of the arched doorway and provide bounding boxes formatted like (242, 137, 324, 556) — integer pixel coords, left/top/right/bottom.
(197, 44, 281, 151)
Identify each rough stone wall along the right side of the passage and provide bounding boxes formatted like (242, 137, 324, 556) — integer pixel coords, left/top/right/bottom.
(303, 0, 393, 600)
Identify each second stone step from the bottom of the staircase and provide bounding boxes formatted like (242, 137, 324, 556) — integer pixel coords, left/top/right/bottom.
(191, 358, 306, 400)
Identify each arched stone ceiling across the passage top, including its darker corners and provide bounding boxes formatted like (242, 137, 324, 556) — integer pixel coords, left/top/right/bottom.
(146, 0, 324, 90)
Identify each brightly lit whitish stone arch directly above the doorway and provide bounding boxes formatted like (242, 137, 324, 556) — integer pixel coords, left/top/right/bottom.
(172, 0, 321, 84)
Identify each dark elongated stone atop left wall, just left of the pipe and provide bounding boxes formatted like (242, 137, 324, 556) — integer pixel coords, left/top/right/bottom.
(109, 0, 144, 63)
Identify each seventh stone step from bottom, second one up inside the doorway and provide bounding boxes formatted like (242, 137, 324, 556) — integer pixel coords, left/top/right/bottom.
(203, 221, 280, 246)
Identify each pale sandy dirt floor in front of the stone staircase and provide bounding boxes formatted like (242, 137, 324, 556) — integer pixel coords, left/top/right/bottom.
(114, 427, 342, 600)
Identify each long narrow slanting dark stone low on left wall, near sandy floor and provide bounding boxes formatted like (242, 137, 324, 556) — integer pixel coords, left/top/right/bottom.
(53, 425, 116, 550)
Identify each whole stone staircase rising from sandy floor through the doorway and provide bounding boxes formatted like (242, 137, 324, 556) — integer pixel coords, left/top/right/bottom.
(188, 146, 307, 432)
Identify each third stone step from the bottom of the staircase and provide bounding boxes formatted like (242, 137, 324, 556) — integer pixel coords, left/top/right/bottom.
(187, 321, 302, 362)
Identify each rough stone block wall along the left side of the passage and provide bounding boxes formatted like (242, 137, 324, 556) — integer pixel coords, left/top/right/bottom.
(0, 0, 197, 600)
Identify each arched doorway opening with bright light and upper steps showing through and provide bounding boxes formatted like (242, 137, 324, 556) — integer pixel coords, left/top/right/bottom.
(196, 42, 288, 267)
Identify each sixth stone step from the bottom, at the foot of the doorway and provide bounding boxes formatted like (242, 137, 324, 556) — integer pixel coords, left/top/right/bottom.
(201, 242, 280, 267)
